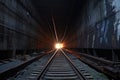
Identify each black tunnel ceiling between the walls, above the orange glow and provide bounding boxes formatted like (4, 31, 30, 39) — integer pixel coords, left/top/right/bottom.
(32, 0, 84, 48)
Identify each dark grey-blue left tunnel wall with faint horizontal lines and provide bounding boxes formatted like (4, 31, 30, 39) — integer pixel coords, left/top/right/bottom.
(0, 0, 40, 59)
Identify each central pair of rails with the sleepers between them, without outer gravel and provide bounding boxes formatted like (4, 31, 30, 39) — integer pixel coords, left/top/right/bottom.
(37, 51, 88, 80)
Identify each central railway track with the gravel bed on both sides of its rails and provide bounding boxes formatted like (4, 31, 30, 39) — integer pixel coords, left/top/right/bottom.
(8, 50, 108, 80)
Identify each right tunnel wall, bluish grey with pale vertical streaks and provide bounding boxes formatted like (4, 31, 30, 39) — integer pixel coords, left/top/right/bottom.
(76, 0, 120, 49)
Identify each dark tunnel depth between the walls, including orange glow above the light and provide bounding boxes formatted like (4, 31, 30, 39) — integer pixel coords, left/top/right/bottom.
(31, 0, 86, 48)
